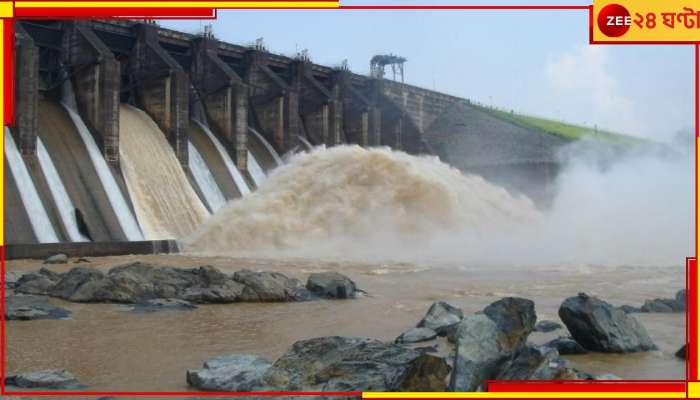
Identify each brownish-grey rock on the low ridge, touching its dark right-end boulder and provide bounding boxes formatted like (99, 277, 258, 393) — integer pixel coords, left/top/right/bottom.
(233, 270, 311, 301)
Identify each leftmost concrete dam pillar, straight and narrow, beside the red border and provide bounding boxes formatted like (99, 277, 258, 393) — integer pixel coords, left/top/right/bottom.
(14, 26, 39, 155)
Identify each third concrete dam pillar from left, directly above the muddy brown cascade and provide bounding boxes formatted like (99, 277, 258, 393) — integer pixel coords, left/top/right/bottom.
(130, 24, 190, 169)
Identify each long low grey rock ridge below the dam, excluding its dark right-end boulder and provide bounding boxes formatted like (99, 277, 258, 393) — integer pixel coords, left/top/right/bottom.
(17, 262, 326, 304)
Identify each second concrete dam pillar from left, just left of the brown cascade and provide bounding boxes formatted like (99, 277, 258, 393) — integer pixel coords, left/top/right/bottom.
(63, 21, 120, 164)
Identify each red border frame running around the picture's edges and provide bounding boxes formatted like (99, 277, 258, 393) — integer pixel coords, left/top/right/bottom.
(0, 0, 700, 399)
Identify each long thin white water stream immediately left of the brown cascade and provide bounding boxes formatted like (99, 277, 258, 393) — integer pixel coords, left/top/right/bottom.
(61, 100, 143, 241)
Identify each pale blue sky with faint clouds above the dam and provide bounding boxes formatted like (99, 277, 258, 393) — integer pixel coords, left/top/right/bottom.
(159, 6, 694, 142)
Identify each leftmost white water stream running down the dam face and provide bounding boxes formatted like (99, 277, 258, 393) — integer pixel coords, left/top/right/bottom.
(5, 127, 59, 243)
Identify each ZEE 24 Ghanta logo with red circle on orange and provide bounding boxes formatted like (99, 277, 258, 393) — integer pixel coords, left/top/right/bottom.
(597, 4, 700, 40)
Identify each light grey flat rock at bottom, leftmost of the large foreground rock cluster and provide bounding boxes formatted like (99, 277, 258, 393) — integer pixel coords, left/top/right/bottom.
(187, 354, 272, 392)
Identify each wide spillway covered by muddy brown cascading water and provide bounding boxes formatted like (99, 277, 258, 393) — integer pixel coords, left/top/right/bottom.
(119, 104, 209, 240)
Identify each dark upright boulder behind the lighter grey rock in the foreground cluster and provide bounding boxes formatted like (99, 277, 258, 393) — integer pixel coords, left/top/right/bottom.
(484, 297, 537, 351)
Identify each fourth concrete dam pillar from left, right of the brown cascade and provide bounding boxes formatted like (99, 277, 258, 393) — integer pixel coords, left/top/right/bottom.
(192, 38, 248, 171)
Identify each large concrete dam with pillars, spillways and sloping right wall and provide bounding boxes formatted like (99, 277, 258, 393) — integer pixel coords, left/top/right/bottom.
(5, 20, 567, 253)
